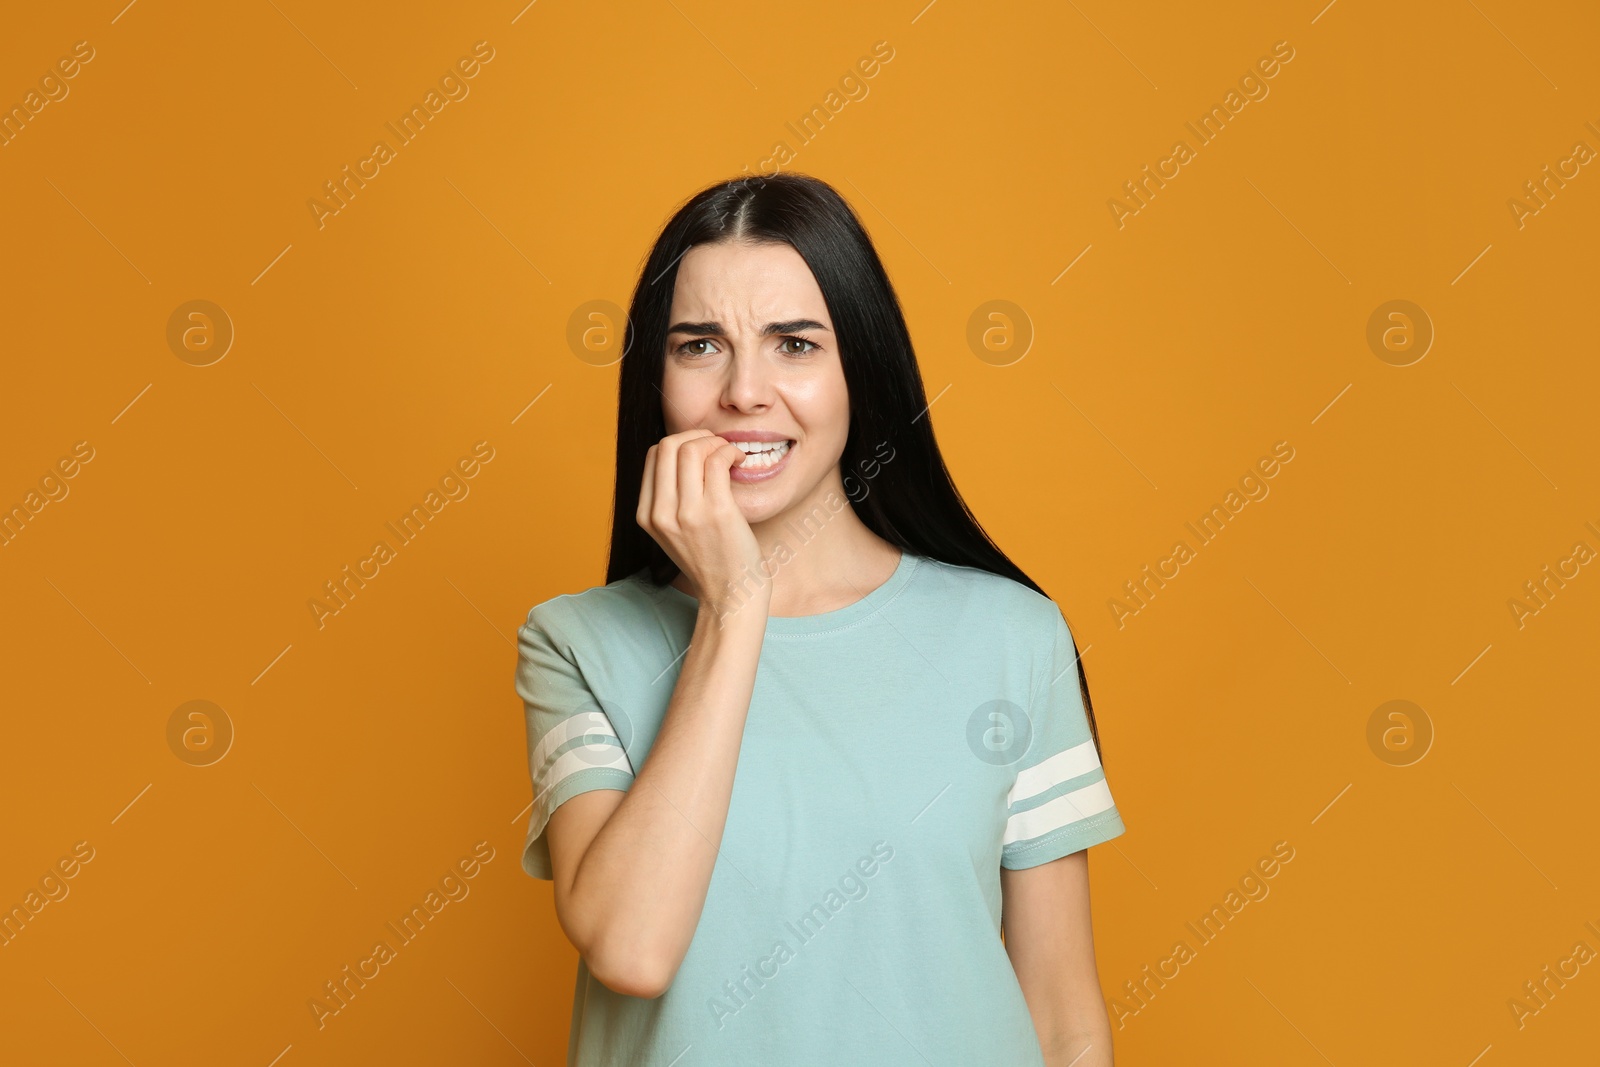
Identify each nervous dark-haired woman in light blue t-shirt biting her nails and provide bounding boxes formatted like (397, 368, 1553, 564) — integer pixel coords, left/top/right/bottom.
(517, 174, 1123, 1067)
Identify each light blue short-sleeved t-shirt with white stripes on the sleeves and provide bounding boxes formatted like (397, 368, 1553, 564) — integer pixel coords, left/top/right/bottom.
(517, 552, 1123, 1067)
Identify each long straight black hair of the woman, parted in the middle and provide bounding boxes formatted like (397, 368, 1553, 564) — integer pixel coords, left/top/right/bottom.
(606, 173, 1099, 749)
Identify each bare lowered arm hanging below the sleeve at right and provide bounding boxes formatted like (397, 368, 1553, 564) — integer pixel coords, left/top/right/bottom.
(1000, 851, 1112, 1067)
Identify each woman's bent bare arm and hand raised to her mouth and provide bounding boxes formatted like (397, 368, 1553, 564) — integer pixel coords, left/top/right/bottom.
(546, 429, 773, 997)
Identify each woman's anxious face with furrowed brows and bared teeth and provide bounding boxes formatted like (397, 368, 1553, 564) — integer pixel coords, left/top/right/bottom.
(661, 242, 850, 525)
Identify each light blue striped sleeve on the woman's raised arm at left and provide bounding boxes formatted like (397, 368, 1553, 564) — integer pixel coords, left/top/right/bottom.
(517, 608, 634, 878)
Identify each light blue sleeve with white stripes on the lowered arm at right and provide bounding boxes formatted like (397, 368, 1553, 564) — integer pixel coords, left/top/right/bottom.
(1000, 609, 1125, 870)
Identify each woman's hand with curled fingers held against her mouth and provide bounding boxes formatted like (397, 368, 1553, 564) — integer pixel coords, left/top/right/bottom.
(635, 429, 768, 617)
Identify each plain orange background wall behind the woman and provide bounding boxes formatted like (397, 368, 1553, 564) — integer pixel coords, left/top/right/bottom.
(0, 0, 1600, 1067)
